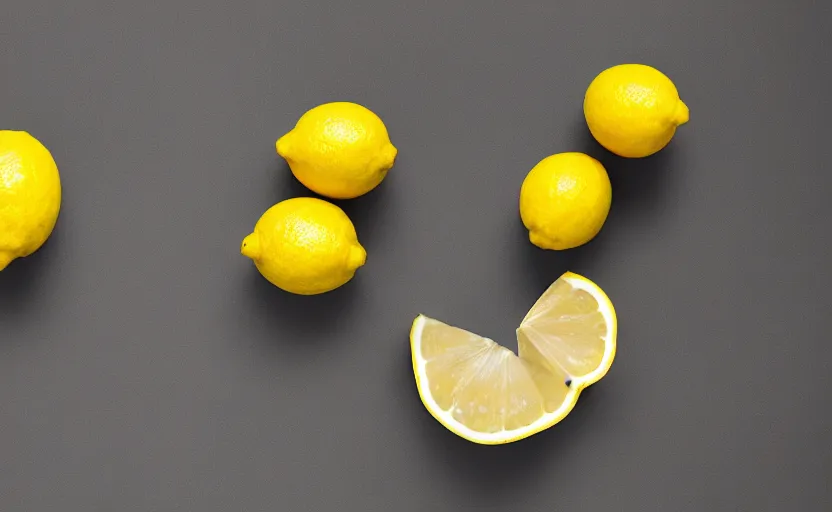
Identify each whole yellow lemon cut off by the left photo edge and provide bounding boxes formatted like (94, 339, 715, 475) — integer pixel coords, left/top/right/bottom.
(0, 130, 61, 270)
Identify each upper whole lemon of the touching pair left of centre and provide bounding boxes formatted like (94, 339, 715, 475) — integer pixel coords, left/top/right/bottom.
(276, 102, 398, 199)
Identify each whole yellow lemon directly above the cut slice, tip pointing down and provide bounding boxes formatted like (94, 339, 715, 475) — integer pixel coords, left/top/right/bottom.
(520, 153, 612, 250)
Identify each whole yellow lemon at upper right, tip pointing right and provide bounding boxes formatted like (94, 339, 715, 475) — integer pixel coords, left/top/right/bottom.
(584, 64, 689, 158)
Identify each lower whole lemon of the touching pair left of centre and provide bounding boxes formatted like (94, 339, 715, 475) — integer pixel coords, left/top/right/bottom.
(240, 197, 367, 295)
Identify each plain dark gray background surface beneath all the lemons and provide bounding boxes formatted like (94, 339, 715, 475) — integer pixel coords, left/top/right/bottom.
(0, 0, 832, 512)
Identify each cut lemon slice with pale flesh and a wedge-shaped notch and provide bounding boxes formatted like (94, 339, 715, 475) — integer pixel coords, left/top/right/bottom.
(410, 272, 616, 444)
